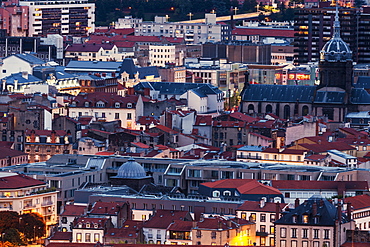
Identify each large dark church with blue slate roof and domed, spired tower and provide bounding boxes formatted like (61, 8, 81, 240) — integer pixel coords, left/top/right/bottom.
(240, 7, 370, 122)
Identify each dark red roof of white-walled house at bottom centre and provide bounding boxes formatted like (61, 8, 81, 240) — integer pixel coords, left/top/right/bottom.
(144, 209, 189, 229)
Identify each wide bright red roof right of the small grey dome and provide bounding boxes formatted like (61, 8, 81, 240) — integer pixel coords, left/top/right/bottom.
(201, 179, 281, 195)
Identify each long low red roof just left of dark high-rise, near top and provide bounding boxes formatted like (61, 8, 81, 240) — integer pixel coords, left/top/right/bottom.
(232, 27, 296, 38)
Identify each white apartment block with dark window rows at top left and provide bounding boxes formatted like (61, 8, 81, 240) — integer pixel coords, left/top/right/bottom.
(19, 0, 95, 37)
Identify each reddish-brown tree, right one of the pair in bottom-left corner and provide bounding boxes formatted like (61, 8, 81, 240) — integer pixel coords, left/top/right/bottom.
(20, 213, 45, 240)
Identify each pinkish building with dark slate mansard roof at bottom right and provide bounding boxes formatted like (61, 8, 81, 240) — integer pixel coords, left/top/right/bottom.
(275, 197, 354, 247)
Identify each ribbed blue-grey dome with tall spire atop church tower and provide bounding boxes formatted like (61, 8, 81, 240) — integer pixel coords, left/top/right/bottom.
(320, 9, 352, 62)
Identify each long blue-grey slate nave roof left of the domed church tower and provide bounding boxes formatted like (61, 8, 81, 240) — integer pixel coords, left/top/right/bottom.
(242, 84, 316, 103)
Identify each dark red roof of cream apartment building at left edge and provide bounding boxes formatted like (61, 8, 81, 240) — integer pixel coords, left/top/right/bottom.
(0, 172, 46, 189)
